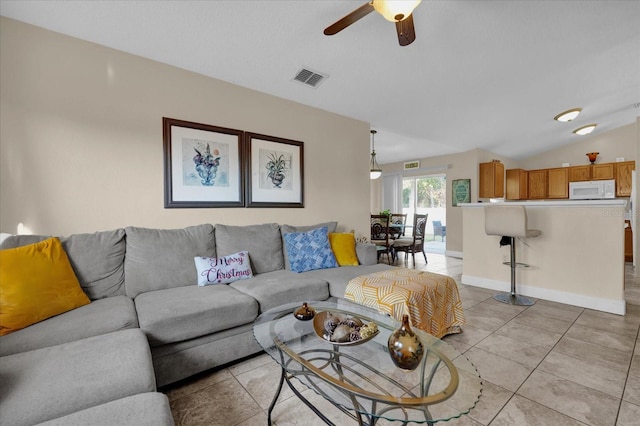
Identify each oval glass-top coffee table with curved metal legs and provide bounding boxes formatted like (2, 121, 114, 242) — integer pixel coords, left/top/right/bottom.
(253, 299, 482, 425)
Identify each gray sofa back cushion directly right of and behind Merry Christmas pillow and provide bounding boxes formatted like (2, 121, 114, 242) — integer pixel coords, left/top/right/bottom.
(216, 223, 284, 274)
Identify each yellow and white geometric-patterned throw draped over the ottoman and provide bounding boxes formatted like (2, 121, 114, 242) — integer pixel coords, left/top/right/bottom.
(344, 268, 465, 338)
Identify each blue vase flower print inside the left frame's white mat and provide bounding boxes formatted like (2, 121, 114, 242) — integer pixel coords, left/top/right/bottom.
(182, 138, 229, 187)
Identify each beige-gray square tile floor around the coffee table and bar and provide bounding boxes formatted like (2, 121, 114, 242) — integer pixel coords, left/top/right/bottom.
(163, 254, 640, 426)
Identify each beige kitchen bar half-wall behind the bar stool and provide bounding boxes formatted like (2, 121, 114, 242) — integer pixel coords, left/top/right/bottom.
(461, 199, 627, 315)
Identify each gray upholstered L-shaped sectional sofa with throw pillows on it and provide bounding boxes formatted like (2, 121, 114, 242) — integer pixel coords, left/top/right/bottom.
(0, 222, 390, 425)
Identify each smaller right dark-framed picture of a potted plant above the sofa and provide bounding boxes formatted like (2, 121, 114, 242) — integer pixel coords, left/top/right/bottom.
(245, 132, 304, 207)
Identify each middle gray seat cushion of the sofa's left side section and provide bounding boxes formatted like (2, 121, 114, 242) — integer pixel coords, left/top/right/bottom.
(0, 329, 155, 425)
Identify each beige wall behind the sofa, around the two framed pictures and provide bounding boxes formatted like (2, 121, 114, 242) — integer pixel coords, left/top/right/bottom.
(0, 18, 370, 235)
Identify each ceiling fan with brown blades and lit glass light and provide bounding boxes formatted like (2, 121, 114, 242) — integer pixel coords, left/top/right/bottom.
(324, 0, 421, 46)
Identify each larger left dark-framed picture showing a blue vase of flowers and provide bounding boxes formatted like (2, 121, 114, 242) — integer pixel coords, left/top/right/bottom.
(162, 117, 245, 208)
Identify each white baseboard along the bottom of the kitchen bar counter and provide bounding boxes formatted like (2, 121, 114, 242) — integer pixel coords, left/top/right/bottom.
(461, 275, 626, 315)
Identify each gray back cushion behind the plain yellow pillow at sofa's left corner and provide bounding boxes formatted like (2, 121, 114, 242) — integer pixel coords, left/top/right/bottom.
(2, 229, 125, 300)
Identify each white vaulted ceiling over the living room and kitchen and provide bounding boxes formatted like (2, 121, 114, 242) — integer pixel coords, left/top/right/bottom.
(0, 0, 640, 164)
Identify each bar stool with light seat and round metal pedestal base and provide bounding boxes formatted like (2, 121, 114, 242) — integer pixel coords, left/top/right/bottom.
(484, 205, 542, 306)
